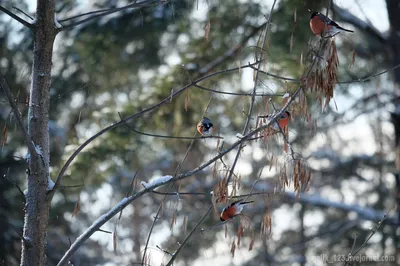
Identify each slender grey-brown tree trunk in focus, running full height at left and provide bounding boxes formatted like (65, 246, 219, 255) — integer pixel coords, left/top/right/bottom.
(21, 0, 58, 265)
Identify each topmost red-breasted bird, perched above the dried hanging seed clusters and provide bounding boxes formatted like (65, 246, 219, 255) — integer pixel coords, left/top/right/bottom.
(310, 12, 354, 36)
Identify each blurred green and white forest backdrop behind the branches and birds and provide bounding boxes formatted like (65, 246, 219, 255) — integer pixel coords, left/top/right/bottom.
(0, 0, 400, 266)
